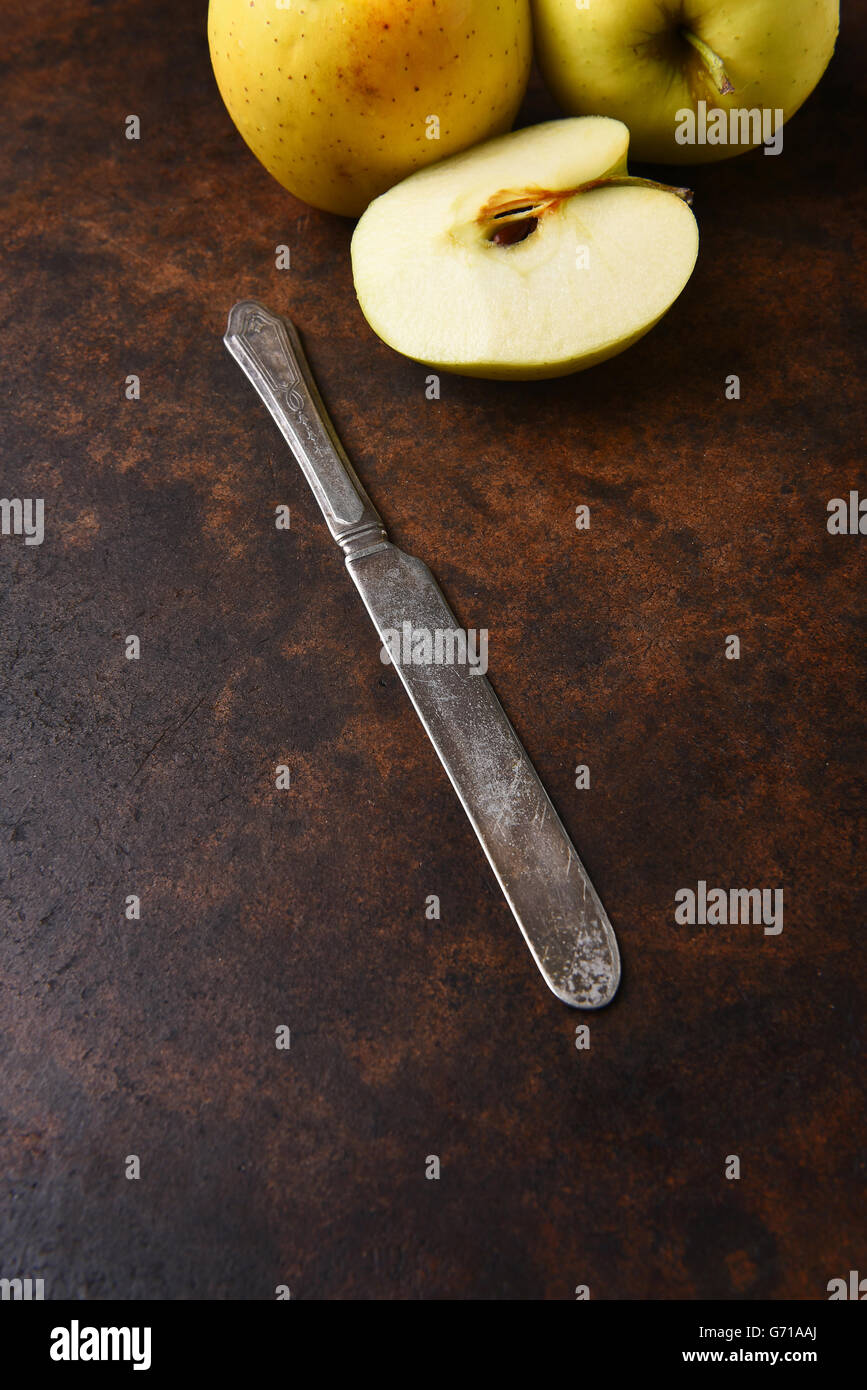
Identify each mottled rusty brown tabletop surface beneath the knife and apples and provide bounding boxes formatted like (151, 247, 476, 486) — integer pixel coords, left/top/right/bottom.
(0, 0, 867, 1300)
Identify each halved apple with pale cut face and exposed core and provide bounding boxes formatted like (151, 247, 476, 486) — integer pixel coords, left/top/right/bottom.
(352, 117, 699, 379)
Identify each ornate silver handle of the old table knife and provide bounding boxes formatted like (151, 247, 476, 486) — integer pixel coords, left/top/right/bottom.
(222, 299, 388, 560)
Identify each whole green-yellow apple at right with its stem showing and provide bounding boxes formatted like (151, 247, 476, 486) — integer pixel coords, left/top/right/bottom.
(532, 0, 839, 164)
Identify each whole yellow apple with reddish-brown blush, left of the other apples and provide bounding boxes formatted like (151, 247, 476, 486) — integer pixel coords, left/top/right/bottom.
(208, 0, 532, 217)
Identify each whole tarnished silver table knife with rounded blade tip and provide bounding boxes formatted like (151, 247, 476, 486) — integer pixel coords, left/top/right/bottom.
(224, 299, 620, 1009)
